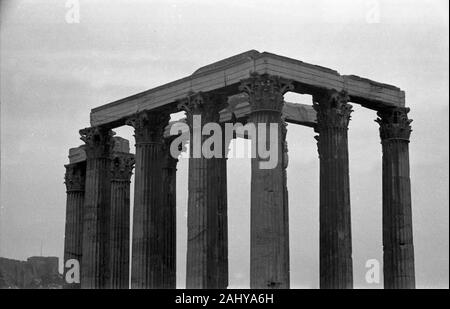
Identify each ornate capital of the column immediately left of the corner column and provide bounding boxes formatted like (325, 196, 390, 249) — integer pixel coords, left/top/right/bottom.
(178, 92, 228, 125)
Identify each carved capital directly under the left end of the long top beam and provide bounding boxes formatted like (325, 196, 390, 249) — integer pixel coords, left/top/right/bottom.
(80, 127, 115, 159)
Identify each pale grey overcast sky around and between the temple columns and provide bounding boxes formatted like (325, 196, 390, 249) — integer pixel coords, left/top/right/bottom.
(0, 0, 449, 288)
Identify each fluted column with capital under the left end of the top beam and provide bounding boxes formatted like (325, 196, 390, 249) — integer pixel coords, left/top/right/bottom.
(80, 127, 113, 288)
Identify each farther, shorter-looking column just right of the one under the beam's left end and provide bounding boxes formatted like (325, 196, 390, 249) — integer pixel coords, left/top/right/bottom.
(110, 153, 134, 289)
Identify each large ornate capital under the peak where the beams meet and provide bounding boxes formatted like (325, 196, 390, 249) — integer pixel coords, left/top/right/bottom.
(239, 73, 294, 112)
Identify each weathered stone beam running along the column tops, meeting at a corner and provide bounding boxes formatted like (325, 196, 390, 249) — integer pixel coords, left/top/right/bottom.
(91, 50, 405, 126)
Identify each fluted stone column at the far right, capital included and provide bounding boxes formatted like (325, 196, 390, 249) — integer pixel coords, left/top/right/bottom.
(377, 108, 415, 289)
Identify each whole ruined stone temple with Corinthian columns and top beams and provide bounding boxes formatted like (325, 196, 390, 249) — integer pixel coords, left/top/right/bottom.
(64, 50, 415, 288)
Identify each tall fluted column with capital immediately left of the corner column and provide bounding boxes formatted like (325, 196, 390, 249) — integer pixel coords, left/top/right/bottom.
(180, 93, 228, 289)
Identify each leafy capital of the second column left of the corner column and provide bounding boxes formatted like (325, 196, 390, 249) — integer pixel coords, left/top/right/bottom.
(125, 111, 170, 144)
